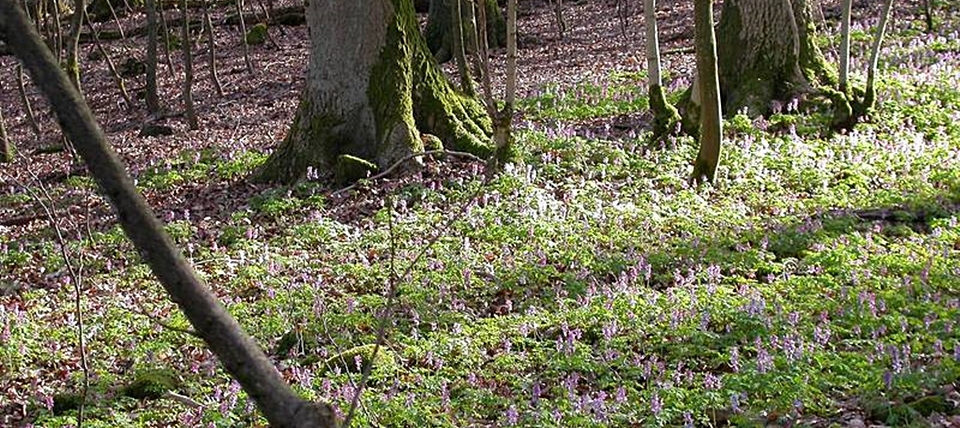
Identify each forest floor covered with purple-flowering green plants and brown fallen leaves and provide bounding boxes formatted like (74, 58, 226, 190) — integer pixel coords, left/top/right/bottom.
(0, 0, 960, 427)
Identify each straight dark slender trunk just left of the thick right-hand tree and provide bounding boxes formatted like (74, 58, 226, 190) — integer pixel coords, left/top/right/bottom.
(690, 0, 722, 183)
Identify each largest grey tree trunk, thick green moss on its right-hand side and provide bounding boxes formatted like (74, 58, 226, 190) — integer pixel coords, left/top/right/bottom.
(254, 0, 491, 183)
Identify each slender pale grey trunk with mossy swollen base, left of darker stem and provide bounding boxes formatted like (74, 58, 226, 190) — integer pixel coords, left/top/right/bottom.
(643, 0, 680, 141)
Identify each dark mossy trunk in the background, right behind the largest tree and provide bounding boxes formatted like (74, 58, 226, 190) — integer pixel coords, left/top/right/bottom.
(424, 0, 507, 62)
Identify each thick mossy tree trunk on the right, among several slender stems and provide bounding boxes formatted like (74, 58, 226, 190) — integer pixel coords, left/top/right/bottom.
(718, 0, 836, 115)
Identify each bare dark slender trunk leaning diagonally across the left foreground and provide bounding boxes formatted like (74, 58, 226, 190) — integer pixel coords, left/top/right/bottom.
(0, 0, 338, 428)
